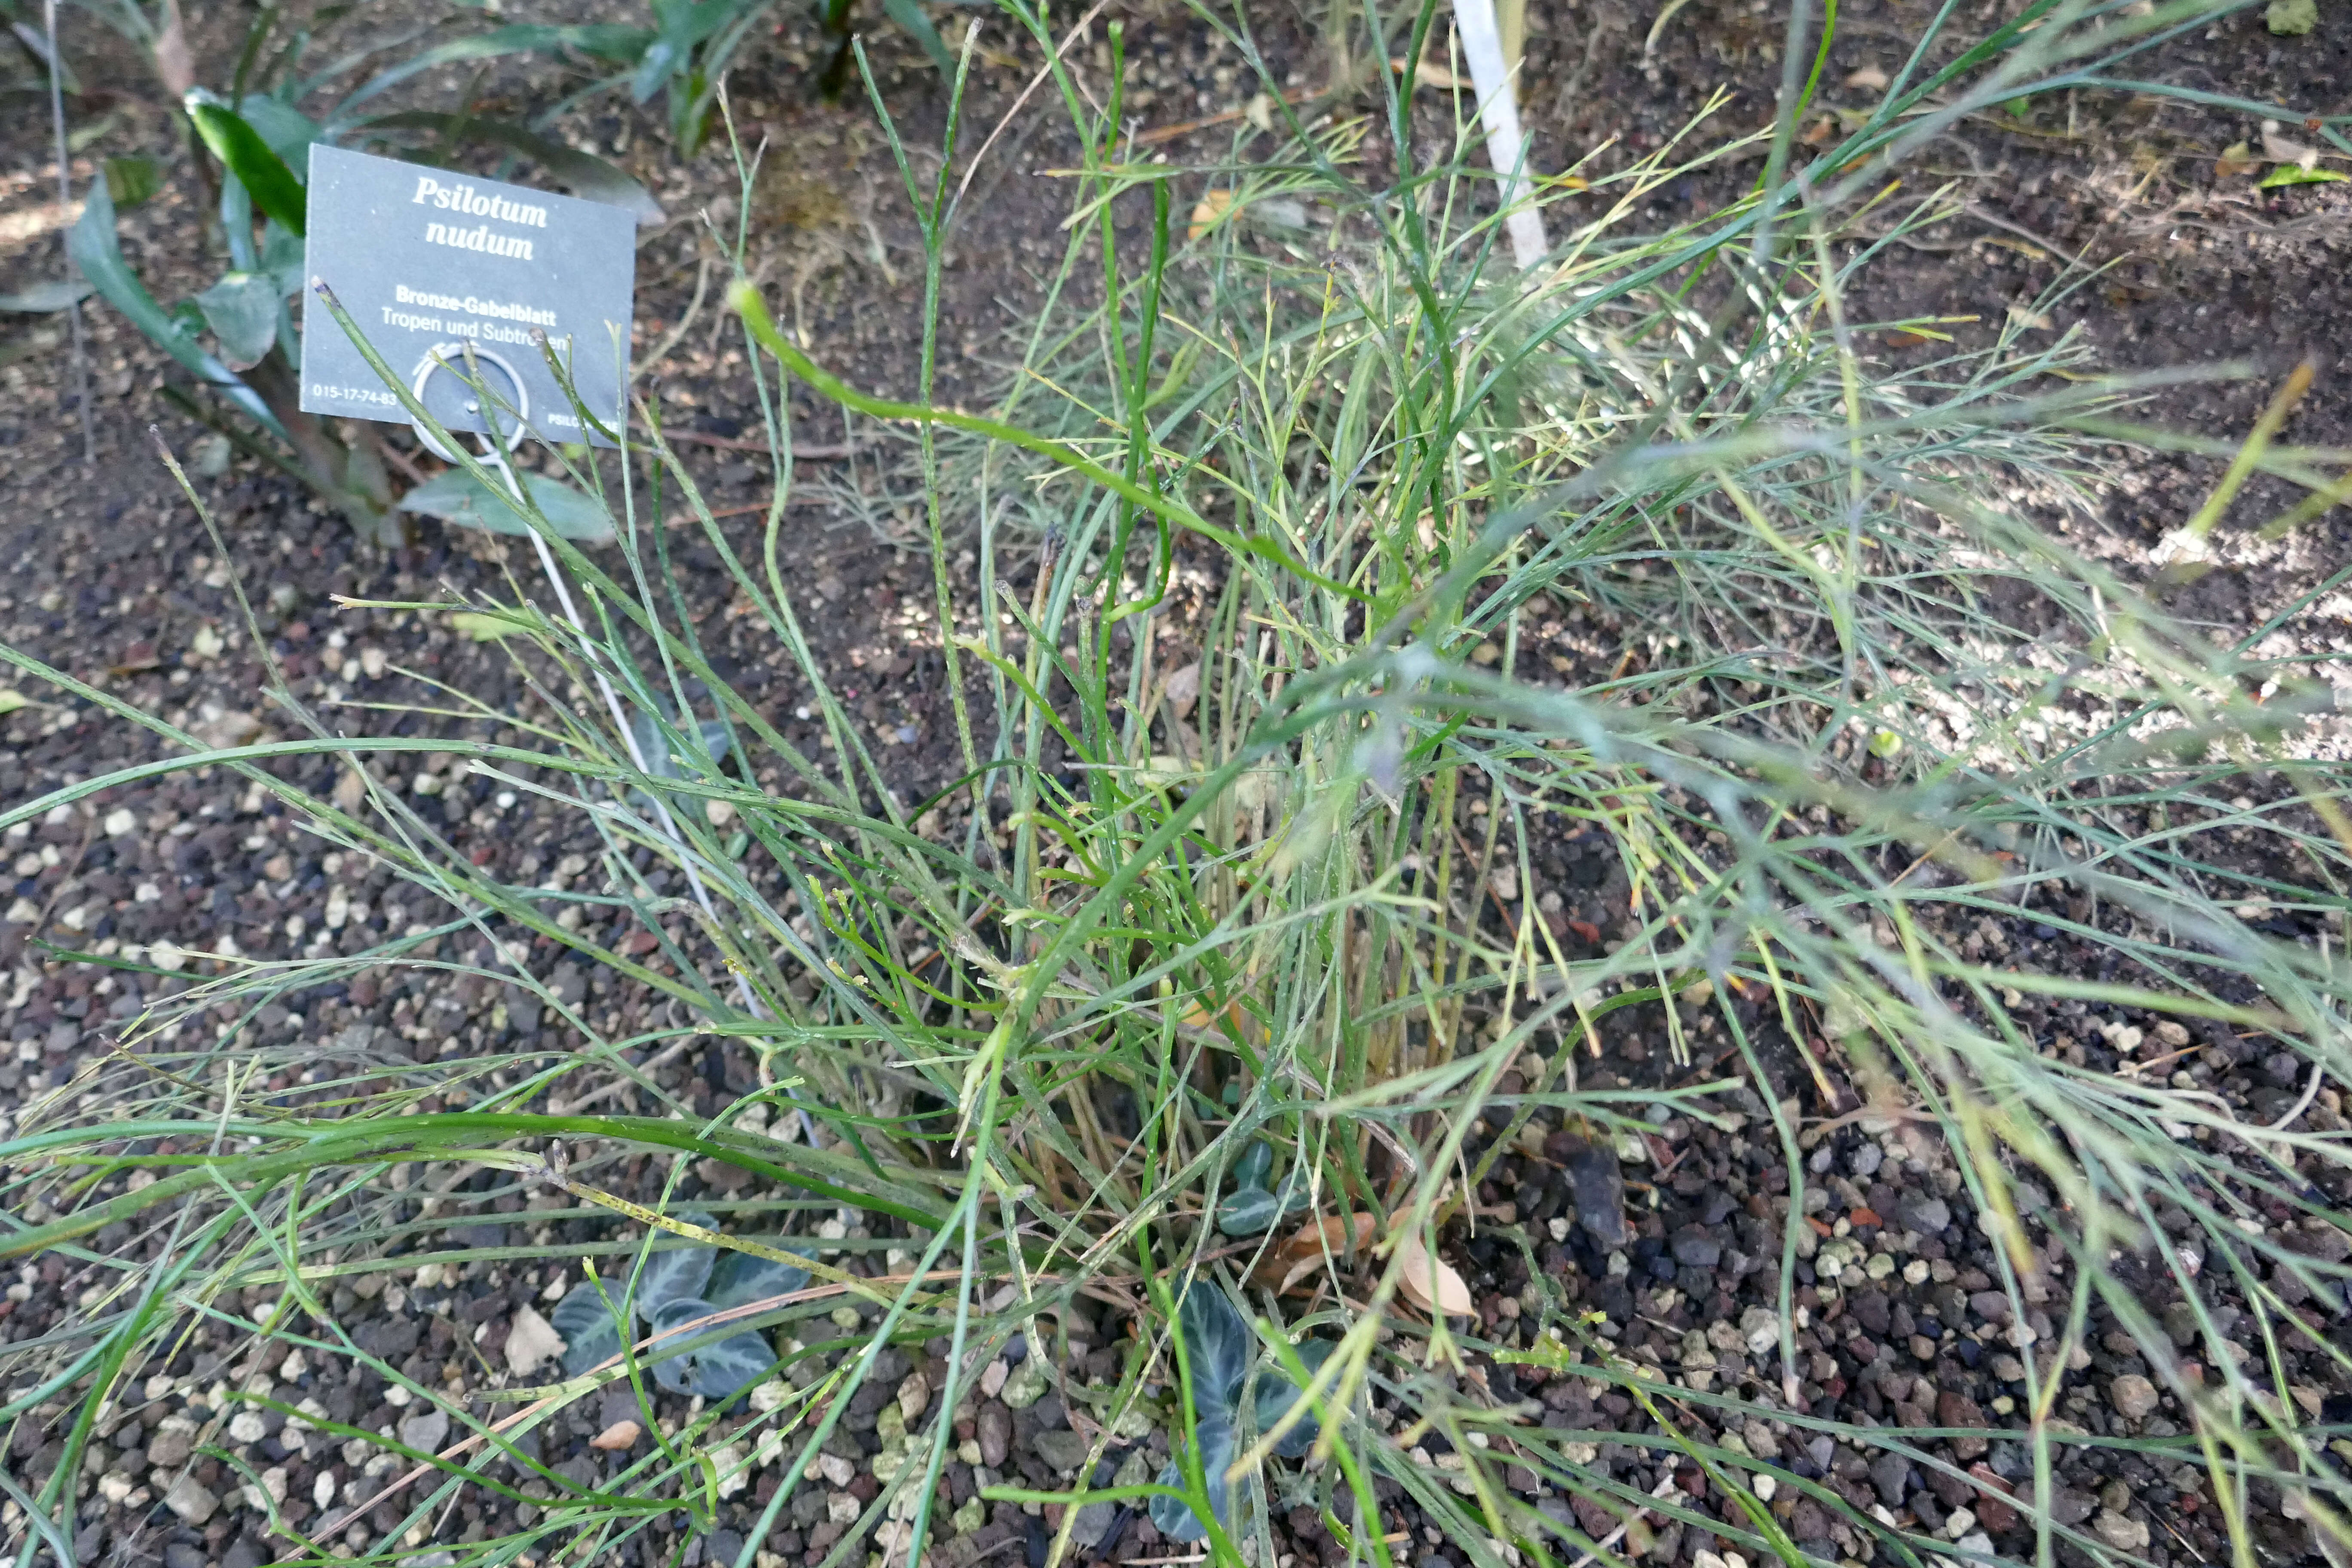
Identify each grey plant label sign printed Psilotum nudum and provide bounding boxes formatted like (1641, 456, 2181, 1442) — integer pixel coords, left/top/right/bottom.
(301, 144, 637, 447)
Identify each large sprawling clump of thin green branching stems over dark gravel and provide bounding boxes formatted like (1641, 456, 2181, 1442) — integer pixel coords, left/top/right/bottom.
(0, 5, 2352, 1568)
